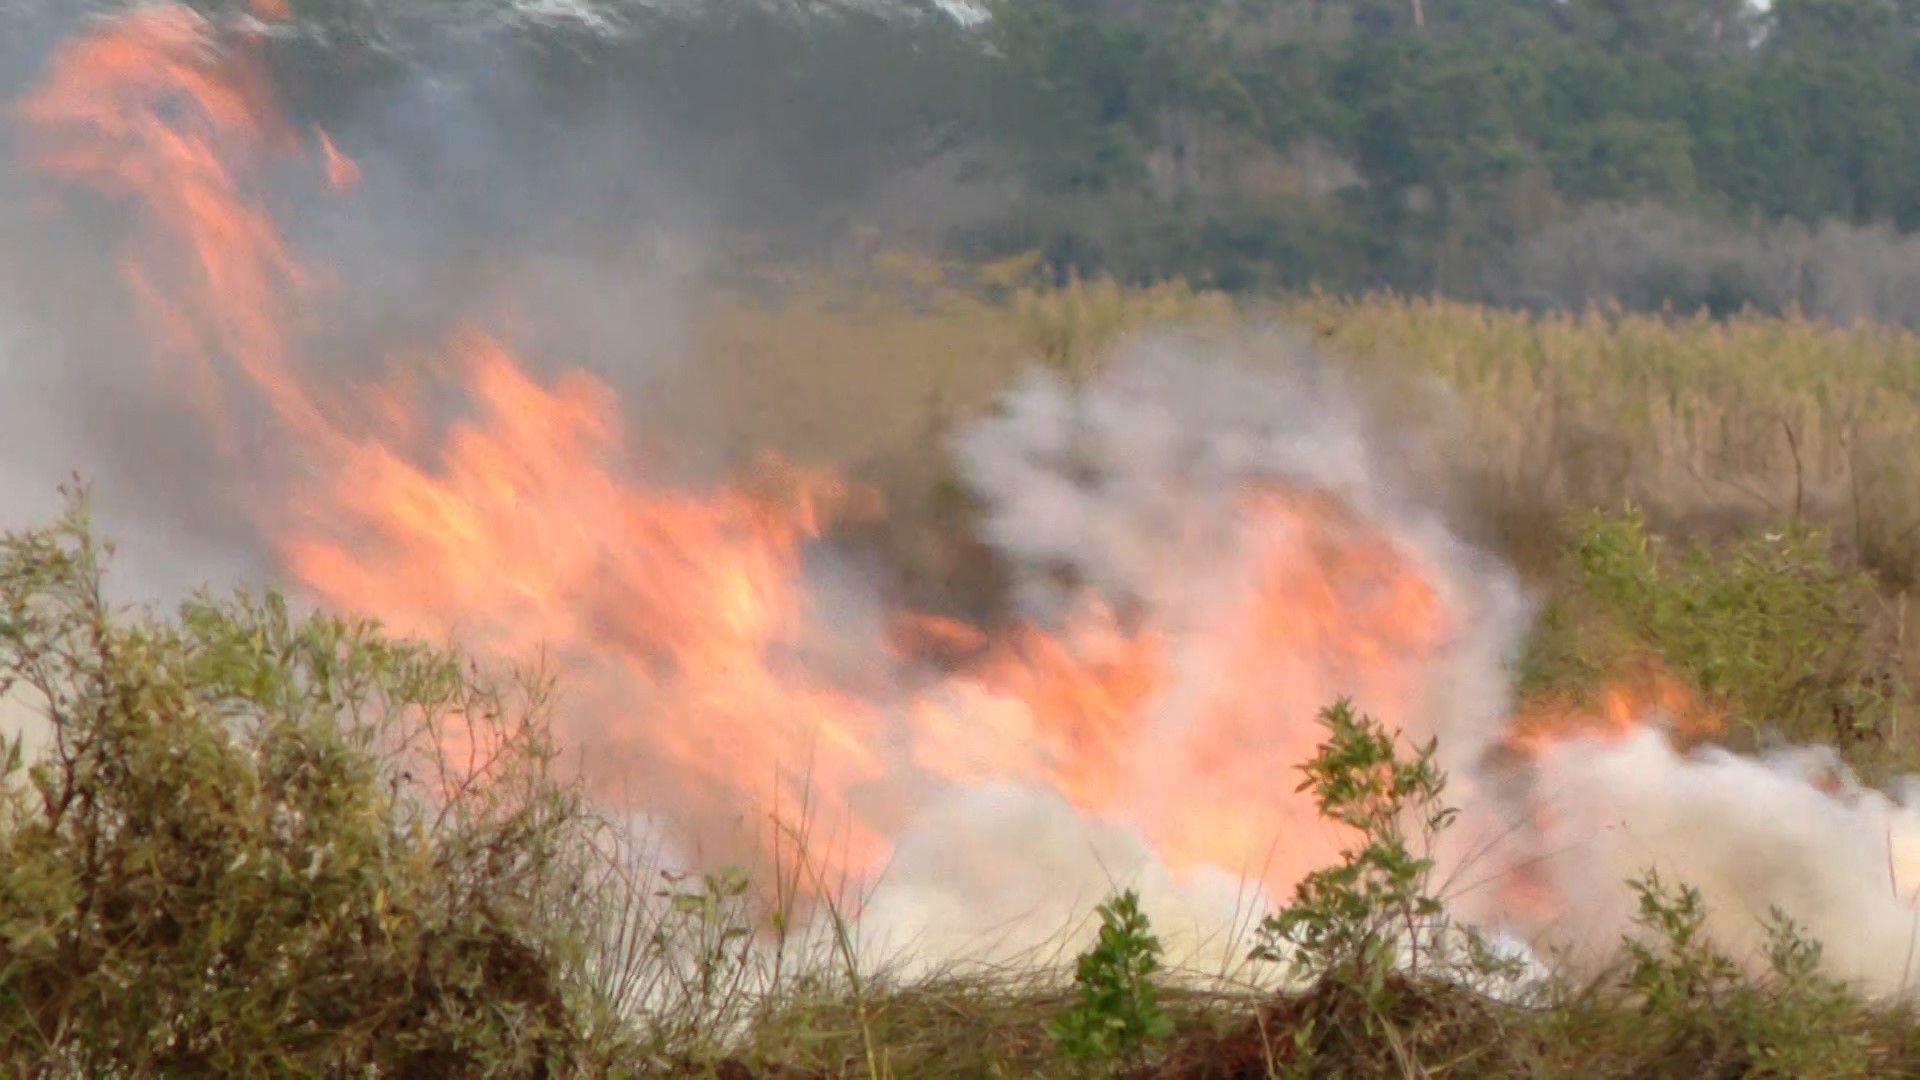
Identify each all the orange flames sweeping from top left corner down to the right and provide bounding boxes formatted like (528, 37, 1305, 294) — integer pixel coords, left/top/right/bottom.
(19, 0, 1781, 926)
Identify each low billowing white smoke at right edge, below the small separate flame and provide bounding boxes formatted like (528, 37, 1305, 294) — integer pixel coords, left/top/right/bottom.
(1534, 726, 1920, 994)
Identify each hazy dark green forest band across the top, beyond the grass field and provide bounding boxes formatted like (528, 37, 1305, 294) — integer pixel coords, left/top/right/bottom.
(30, 0, 1920, 325)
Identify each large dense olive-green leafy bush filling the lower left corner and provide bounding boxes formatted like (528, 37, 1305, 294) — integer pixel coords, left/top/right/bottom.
(0, 486, 609, 1076)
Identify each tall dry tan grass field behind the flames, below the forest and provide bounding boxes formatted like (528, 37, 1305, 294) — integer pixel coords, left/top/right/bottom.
(668, 258, 1920, 590)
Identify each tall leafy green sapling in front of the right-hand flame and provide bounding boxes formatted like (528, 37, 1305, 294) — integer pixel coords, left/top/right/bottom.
(1254, 700, 1453, 1007)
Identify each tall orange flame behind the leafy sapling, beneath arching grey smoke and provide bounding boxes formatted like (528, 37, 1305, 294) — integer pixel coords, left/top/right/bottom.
(1121, 492, 1453, 883)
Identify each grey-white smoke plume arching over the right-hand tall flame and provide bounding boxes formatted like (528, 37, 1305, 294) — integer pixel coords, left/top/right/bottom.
(956, 327, 1530, 753)
